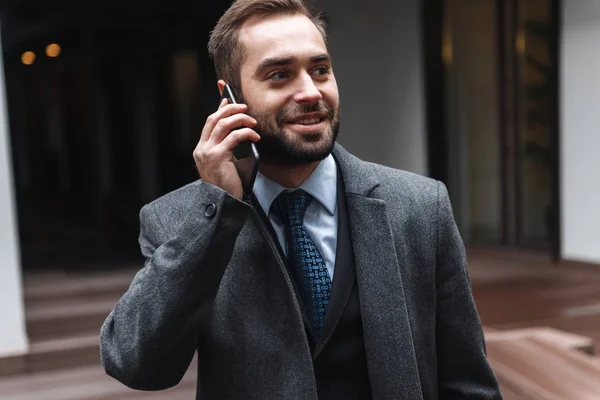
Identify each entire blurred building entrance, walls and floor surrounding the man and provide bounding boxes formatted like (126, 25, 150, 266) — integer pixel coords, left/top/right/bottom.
(0, 0, 600, 400)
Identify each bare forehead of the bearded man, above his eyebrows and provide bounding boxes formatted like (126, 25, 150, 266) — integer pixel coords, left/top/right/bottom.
(240, 15, 327, 68)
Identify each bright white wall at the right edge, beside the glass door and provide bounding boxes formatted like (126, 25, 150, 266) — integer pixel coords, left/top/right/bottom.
(560, 0, 600, 262)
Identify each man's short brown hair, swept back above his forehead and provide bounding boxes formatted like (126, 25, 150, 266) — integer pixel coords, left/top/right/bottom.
(208, 0, 327, 94)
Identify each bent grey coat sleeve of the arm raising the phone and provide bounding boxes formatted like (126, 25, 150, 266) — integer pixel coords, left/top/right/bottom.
(100, 182, 250, 390)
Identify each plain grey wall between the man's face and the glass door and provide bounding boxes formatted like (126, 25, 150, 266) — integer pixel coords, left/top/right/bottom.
(317, 0, 427, 174)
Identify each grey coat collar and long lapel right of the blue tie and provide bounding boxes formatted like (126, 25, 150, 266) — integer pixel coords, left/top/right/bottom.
(334, 145, 422, 399)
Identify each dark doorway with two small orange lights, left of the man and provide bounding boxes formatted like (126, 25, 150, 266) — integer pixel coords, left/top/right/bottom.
(0, 1, 229, 269)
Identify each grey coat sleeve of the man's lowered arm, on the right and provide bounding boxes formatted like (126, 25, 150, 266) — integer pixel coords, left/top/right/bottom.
(436, 182, 502, 399)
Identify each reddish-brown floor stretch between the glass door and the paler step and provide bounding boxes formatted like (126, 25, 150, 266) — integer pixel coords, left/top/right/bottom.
(469, 250, 600, 354)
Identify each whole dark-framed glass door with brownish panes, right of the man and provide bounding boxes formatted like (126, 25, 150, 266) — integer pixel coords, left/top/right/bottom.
(424, 0, 559, 256)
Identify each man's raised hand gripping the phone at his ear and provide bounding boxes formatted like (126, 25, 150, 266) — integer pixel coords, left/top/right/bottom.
(193, 82, 260, 200)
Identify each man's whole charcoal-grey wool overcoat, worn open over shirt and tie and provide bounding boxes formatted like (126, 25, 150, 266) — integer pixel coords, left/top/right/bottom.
(101, 145, 501, 400)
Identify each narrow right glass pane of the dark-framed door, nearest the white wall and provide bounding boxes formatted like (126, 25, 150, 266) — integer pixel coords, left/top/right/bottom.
(517, 0, 555, 247)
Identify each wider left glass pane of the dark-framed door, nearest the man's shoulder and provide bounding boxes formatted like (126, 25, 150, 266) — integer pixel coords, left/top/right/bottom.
(442, 0, 502, 244)
